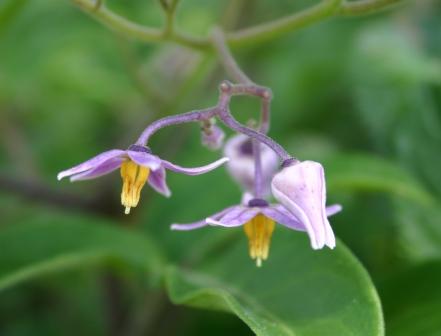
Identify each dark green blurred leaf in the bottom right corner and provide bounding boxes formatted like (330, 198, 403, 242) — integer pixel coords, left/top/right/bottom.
(381, 259, 441, 336)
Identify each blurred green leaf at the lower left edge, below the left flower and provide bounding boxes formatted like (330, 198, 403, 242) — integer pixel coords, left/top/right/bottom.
(0, 215, 163, 289)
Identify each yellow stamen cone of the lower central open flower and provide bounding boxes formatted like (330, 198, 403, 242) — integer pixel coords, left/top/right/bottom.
(243, 214, 276, 267)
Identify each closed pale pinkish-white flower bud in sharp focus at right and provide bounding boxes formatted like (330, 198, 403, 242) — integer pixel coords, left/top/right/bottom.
(271, 161, 335, 249)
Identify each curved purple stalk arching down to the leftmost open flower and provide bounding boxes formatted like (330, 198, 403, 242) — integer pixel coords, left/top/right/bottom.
(136, 107, 217, 146)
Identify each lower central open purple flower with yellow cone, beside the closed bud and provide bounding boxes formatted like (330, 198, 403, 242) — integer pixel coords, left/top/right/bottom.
(171, 199, 341, 267)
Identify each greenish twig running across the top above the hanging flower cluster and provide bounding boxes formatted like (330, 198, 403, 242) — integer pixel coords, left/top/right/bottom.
(71, 0, 410, 50)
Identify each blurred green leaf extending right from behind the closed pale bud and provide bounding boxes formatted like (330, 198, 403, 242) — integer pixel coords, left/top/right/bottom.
(324, 154, 433, 205)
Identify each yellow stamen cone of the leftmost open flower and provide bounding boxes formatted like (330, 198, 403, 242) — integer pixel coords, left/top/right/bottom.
(121, 160, 150, 215)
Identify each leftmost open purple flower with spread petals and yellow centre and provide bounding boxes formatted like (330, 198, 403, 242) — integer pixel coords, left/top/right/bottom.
(57, 145, 228, 214)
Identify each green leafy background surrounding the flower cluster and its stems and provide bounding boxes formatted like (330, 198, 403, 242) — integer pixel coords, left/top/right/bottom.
(0, 0, 441, 336)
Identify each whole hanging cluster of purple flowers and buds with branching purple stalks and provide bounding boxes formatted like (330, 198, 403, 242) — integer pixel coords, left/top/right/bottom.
(58, 82, 341, 266)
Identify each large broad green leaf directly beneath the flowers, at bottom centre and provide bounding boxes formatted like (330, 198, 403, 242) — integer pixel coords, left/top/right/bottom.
(166, 228, 383, 336)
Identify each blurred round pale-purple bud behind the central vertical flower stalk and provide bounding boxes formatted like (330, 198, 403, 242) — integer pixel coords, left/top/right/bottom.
(224, 134, 279, 195)
